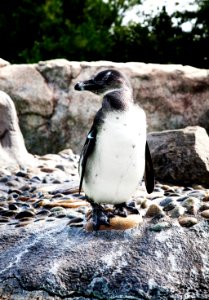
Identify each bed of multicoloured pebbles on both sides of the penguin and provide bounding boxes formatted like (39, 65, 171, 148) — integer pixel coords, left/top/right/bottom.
(0, 162, 209, 232)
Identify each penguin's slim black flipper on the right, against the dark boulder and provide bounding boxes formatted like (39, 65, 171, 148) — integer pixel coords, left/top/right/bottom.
(144, 142, 155, 194)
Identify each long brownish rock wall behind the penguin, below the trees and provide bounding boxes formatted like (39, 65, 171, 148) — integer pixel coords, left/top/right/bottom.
(0, 59, 209, 154)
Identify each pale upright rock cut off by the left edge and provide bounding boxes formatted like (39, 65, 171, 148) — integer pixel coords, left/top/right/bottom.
(0, 91, 34, 168)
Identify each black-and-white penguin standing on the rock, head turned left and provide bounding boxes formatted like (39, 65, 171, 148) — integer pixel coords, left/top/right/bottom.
(74, 69, 154, 230)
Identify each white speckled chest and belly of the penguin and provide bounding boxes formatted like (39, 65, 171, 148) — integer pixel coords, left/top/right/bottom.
(83, 105, 146, 204)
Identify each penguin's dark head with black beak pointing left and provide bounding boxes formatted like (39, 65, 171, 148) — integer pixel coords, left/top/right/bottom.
(75, 69, 131, 95)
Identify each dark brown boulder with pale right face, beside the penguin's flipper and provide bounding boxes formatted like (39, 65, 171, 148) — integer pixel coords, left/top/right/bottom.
(148, 126, 209, 186)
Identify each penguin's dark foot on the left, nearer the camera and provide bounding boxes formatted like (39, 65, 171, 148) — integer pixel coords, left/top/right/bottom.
(92, 203, 112, 231)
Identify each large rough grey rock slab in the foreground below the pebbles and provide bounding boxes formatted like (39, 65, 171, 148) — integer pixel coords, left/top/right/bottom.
(0, 211, 209, 300)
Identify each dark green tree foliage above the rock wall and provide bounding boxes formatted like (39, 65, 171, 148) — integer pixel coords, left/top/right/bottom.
(0, 0, 209, 68)
